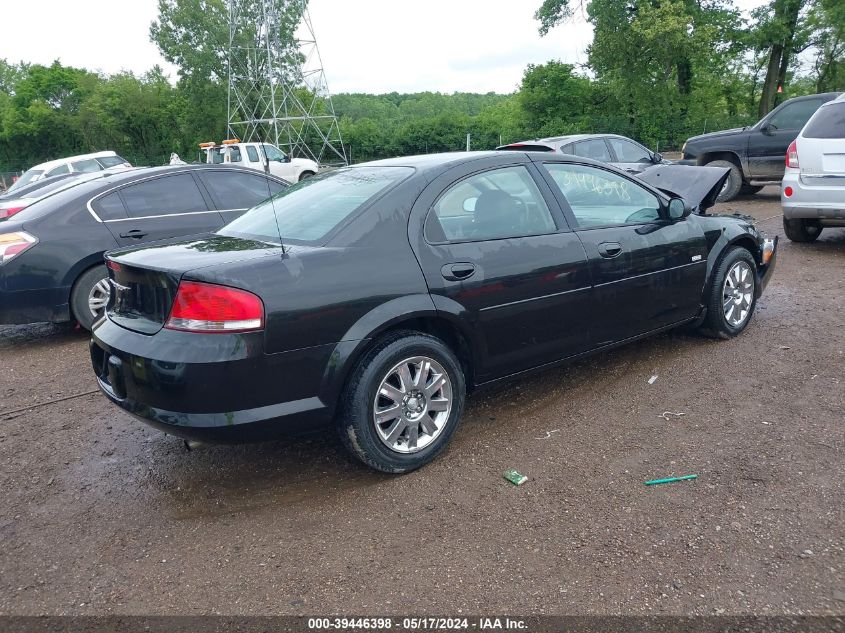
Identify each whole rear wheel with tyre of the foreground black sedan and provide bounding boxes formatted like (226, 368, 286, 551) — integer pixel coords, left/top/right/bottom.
(338, 331, 466, 473)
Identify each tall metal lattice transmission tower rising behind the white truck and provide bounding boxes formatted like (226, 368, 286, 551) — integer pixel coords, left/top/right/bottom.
(228, 0, 347, 165)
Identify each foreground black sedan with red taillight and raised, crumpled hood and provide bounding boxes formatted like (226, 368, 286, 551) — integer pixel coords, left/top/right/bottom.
(91, 151, 777, 473)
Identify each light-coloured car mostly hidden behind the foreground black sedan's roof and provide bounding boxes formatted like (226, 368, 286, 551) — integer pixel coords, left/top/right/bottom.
(496, 134, 668, 174)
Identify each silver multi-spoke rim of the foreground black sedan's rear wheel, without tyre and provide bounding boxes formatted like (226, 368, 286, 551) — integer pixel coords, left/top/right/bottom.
(373, 356, 452, 453)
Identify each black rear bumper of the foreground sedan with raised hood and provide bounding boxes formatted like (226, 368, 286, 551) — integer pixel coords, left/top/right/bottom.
(90, 319, 334, 443)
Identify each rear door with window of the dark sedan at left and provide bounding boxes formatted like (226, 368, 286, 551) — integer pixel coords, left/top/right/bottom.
(93, 172, 223, 246)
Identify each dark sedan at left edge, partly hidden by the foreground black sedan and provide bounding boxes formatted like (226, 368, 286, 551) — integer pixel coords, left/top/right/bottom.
(0, 165, 287, 329)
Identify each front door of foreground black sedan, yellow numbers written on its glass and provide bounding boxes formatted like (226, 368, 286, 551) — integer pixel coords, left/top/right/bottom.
(544, 158, 707, 347)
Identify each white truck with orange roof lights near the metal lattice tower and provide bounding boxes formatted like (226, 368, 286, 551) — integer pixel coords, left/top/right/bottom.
(200, 139, 319, 182)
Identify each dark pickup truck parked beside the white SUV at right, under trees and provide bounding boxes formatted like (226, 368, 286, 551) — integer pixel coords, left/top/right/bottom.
(679, 92, 842, 202)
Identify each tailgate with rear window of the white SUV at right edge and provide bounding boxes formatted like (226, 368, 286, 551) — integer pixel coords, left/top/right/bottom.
(797, 101, 845, 187)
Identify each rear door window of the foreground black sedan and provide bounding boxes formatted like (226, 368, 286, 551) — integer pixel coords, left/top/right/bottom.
(425, 166, 557, 243)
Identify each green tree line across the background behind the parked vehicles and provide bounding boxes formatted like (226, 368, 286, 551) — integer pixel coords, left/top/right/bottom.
(0, 0, 845, 171)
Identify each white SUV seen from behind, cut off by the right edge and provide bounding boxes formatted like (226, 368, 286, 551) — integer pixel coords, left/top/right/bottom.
(780, 95, 845, 242)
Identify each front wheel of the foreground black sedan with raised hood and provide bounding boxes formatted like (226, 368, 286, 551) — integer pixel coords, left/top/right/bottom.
(701, 246, 757, 339)
